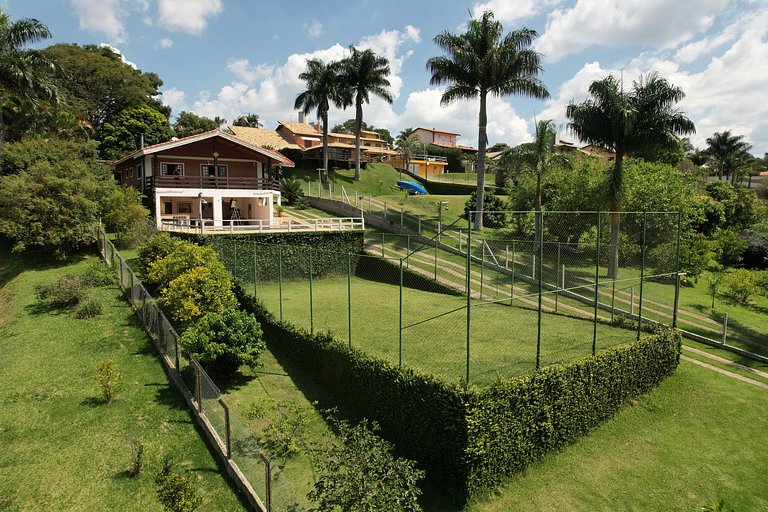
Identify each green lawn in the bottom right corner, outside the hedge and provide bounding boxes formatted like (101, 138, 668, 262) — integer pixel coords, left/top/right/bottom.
(468, 362, 768, 512)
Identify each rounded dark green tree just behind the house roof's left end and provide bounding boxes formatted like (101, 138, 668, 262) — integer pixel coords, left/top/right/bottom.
(99, 105, 173, 160)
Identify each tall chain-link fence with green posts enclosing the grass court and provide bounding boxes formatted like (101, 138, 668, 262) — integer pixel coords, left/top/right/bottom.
(212, 212, 679, 384)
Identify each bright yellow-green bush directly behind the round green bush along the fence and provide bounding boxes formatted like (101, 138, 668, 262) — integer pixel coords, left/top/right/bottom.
(161, 259, 236, 328)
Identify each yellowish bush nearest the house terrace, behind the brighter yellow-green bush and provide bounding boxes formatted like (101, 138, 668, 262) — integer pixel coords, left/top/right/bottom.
(147, 242, 221, 289)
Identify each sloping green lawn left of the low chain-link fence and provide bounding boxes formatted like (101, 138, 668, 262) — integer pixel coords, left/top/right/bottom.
(0, 251, 245, 511)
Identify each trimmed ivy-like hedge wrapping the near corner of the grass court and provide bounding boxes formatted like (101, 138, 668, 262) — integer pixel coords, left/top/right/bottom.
(236, 288, 680, 503)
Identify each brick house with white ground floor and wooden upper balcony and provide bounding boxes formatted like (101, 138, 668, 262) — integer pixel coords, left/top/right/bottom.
(114, 130, 294, 228)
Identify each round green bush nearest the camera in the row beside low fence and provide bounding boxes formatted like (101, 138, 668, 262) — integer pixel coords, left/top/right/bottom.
(179, 308, 266, 376)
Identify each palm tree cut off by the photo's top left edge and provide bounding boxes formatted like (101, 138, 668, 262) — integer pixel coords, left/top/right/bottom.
(0, 11, 57, 148)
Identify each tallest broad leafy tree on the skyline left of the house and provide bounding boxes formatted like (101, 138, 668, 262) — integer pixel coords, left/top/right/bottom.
(42, 44, 171, 140)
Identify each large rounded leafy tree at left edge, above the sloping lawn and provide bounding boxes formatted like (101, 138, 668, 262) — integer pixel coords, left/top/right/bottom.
(0, 139, 115, 259)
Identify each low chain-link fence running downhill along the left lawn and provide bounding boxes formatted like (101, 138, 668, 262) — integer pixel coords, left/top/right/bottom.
(98, 231, 274, 511)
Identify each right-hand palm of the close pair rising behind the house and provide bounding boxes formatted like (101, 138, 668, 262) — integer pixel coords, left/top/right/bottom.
(342, 46, 392, 181)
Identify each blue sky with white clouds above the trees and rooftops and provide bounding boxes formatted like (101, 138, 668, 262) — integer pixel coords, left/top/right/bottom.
(6, 0, 768, 155)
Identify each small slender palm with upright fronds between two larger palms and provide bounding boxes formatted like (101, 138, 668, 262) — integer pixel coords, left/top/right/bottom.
(502, 119, 568, 250)
